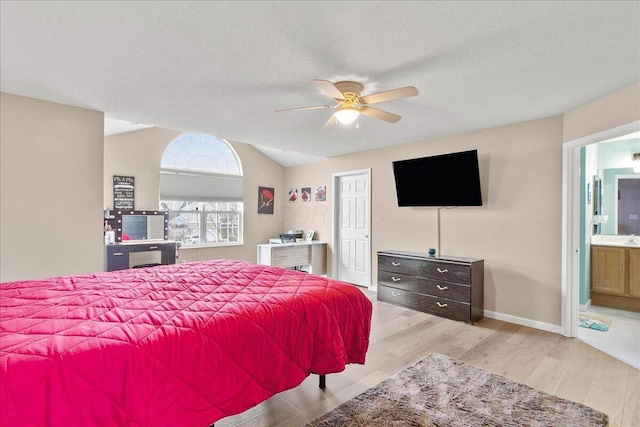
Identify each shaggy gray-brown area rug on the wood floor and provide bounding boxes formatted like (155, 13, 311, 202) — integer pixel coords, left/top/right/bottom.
(306, 353, 609, 427)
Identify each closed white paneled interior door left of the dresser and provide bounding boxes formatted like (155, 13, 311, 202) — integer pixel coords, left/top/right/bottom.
(334, 170, 371, 287)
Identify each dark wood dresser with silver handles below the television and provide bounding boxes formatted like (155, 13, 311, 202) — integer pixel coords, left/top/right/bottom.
(378, 250, 484, 323)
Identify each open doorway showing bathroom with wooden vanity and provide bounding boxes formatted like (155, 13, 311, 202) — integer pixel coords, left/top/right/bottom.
(563, 122, 640, 368)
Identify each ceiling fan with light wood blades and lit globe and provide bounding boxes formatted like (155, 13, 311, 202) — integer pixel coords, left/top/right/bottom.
(276, 79, 418, 130)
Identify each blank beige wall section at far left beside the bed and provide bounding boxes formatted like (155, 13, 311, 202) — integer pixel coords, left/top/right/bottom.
(0, 93, 104, 282)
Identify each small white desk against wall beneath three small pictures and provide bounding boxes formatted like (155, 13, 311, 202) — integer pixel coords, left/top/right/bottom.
(258, 240, 327, 275)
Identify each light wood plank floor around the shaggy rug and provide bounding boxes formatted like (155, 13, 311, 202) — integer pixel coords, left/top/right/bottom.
(215, 290, 640, 427)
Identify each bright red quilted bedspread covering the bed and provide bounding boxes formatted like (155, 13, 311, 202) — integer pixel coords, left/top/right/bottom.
(0, 260, 372, 427)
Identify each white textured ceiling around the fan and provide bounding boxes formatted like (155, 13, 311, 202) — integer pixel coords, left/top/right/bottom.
(0, 1, 640, 166)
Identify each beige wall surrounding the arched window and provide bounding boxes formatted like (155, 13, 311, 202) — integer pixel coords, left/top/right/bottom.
(104, 128, 286, 262)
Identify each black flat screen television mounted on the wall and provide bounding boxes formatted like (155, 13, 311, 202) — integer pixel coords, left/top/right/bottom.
(393, 150, 482, 206)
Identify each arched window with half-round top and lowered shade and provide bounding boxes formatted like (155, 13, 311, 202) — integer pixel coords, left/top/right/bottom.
(160, 133, 243, 246)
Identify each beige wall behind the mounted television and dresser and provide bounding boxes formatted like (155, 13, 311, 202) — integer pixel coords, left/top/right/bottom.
(285, 116, 562, 325)
